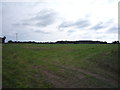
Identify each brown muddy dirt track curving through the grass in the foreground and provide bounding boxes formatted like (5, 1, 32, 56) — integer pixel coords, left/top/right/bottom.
(32, 64, 117, 88)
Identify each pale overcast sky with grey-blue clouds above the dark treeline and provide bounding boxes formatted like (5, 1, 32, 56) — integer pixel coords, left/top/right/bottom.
(0, 0, 119, 42)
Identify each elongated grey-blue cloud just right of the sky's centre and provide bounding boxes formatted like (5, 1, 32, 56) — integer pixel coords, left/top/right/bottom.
(59, 19, 90, 28)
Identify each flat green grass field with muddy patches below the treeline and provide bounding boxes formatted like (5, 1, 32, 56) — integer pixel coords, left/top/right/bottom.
(2, 44, 118, 88)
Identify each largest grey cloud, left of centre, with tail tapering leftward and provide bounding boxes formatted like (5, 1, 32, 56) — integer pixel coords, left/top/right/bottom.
(13, 9, 57, 27)
